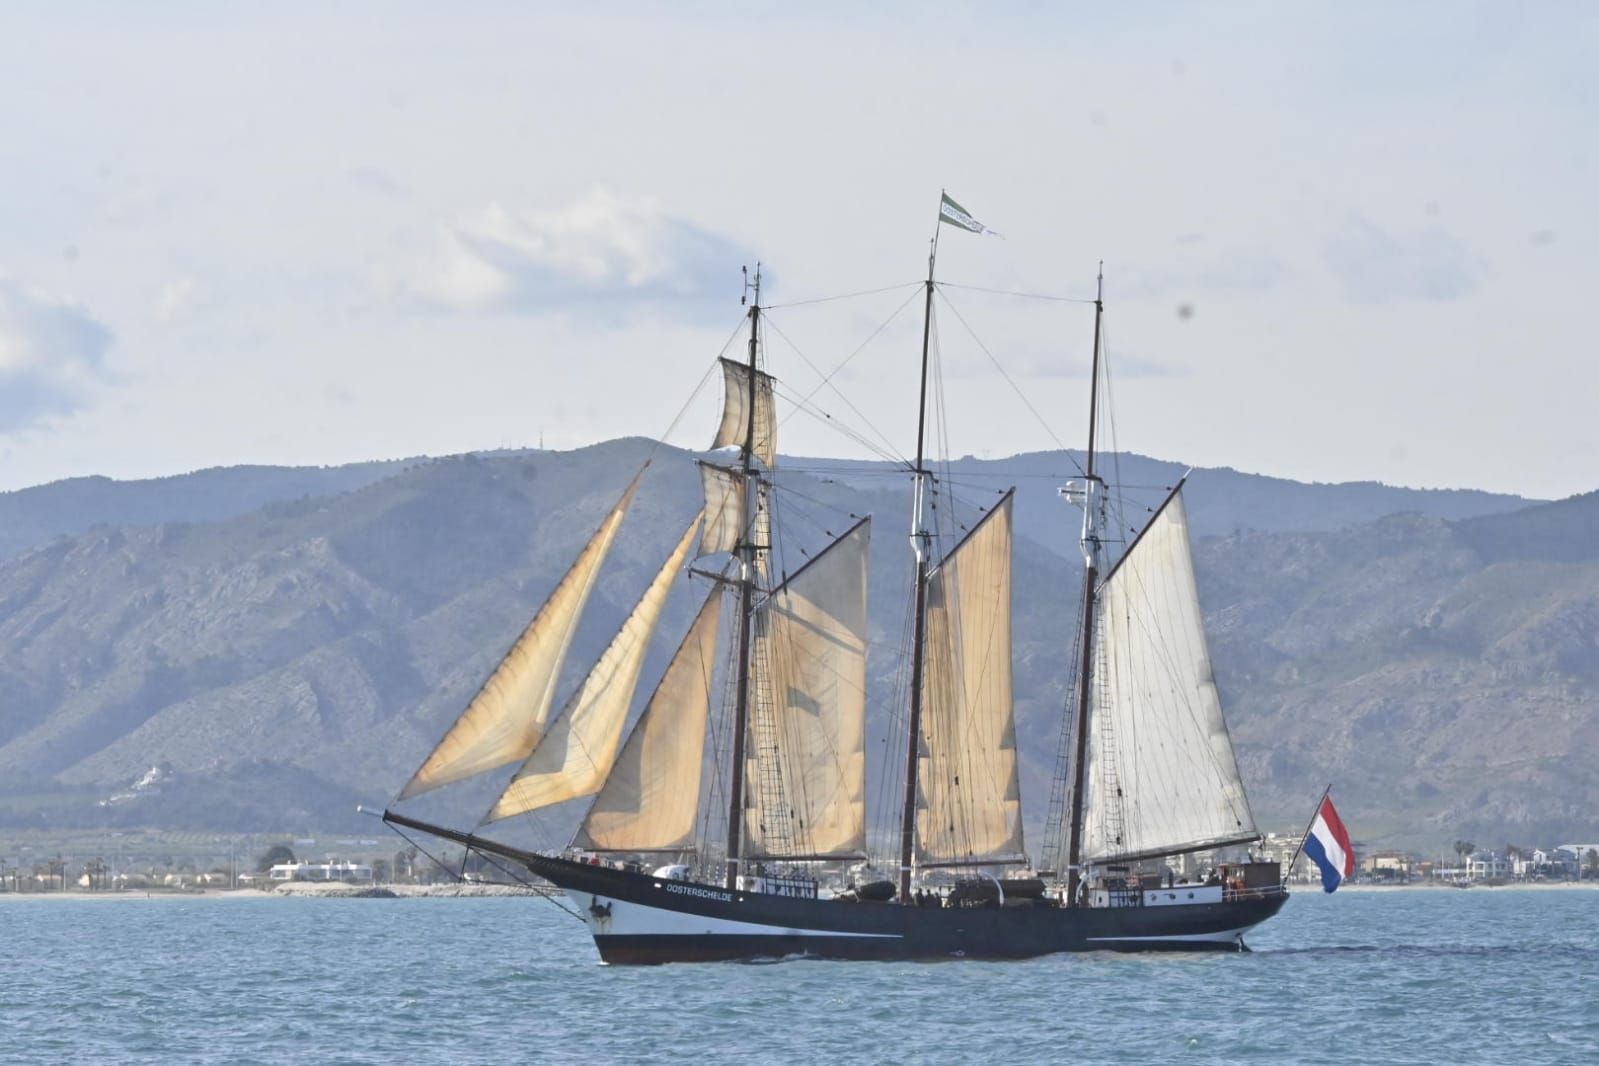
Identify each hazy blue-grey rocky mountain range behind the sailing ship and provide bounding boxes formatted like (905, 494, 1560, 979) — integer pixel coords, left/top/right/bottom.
(0, 441, 1599, 842)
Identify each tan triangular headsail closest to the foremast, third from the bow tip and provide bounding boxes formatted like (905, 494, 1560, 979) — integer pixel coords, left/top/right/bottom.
(572, 588, 723, 852)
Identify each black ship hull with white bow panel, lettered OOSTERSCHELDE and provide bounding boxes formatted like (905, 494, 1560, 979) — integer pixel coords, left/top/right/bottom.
(389, 815, 1287, 965)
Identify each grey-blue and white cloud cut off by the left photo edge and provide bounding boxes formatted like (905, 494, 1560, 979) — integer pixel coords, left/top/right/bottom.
(0, 278, 112, 433)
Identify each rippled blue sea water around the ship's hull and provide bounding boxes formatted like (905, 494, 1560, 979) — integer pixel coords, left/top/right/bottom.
(0, 889, 1599, 1066)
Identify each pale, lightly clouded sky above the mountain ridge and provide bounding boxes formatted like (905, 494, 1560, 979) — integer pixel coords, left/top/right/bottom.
(0, 0, 1599, 497)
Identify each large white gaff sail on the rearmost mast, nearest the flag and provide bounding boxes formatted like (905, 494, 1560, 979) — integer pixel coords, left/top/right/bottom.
(1083, 486, 1258, 860)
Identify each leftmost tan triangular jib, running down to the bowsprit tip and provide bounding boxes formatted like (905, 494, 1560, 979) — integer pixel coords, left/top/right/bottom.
(398, 471, 643, 799)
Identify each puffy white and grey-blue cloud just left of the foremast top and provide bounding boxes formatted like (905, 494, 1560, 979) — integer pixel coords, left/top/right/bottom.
(403, 190, 753, 310)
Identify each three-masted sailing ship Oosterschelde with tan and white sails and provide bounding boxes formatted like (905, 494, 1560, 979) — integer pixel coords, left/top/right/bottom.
(382, 197, 1287, 964)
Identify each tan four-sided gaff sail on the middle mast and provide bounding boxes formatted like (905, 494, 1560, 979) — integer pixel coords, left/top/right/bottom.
(916, 494, 1022, 863)
